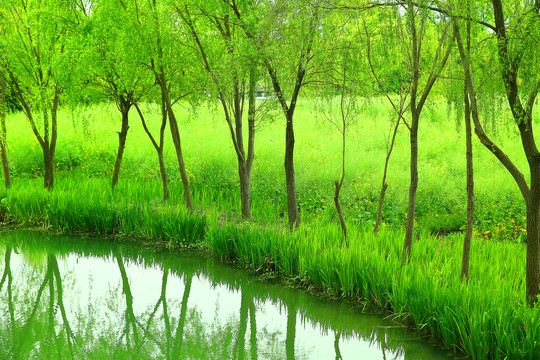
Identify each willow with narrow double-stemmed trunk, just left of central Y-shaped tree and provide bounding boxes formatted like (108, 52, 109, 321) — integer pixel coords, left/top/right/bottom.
(176, 1, 258, 219)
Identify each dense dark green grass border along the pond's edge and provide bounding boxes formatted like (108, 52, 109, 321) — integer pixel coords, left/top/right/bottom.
(0, 180, 540, 359)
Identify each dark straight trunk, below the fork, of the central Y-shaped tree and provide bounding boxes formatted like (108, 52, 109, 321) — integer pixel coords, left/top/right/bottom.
(284, 114, 300, 230)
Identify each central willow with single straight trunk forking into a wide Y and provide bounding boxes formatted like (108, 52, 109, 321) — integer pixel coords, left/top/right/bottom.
(229, 0, 323, 230)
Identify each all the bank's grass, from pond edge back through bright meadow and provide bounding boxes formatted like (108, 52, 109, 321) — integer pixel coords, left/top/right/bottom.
(0, 97, 540, 359)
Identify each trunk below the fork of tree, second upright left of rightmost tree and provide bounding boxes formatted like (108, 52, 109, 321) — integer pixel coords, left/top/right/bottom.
(402, 114, 418, 264)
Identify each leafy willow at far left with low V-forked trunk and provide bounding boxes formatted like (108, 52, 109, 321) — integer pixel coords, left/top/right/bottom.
(0, 0, 81, 189)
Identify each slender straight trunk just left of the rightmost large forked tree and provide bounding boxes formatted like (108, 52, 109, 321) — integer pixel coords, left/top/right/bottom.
(461, 83, 474, 282)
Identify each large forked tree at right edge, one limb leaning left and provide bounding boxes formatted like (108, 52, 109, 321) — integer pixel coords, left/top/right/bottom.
(454, 0, 540, 305)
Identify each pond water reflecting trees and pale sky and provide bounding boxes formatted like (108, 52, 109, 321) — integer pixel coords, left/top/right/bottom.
(0, 232, 462, 360)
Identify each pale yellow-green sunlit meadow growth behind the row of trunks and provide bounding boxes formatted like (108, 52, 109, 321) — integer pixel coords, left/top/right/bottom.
(3, 99, 527, 240)
